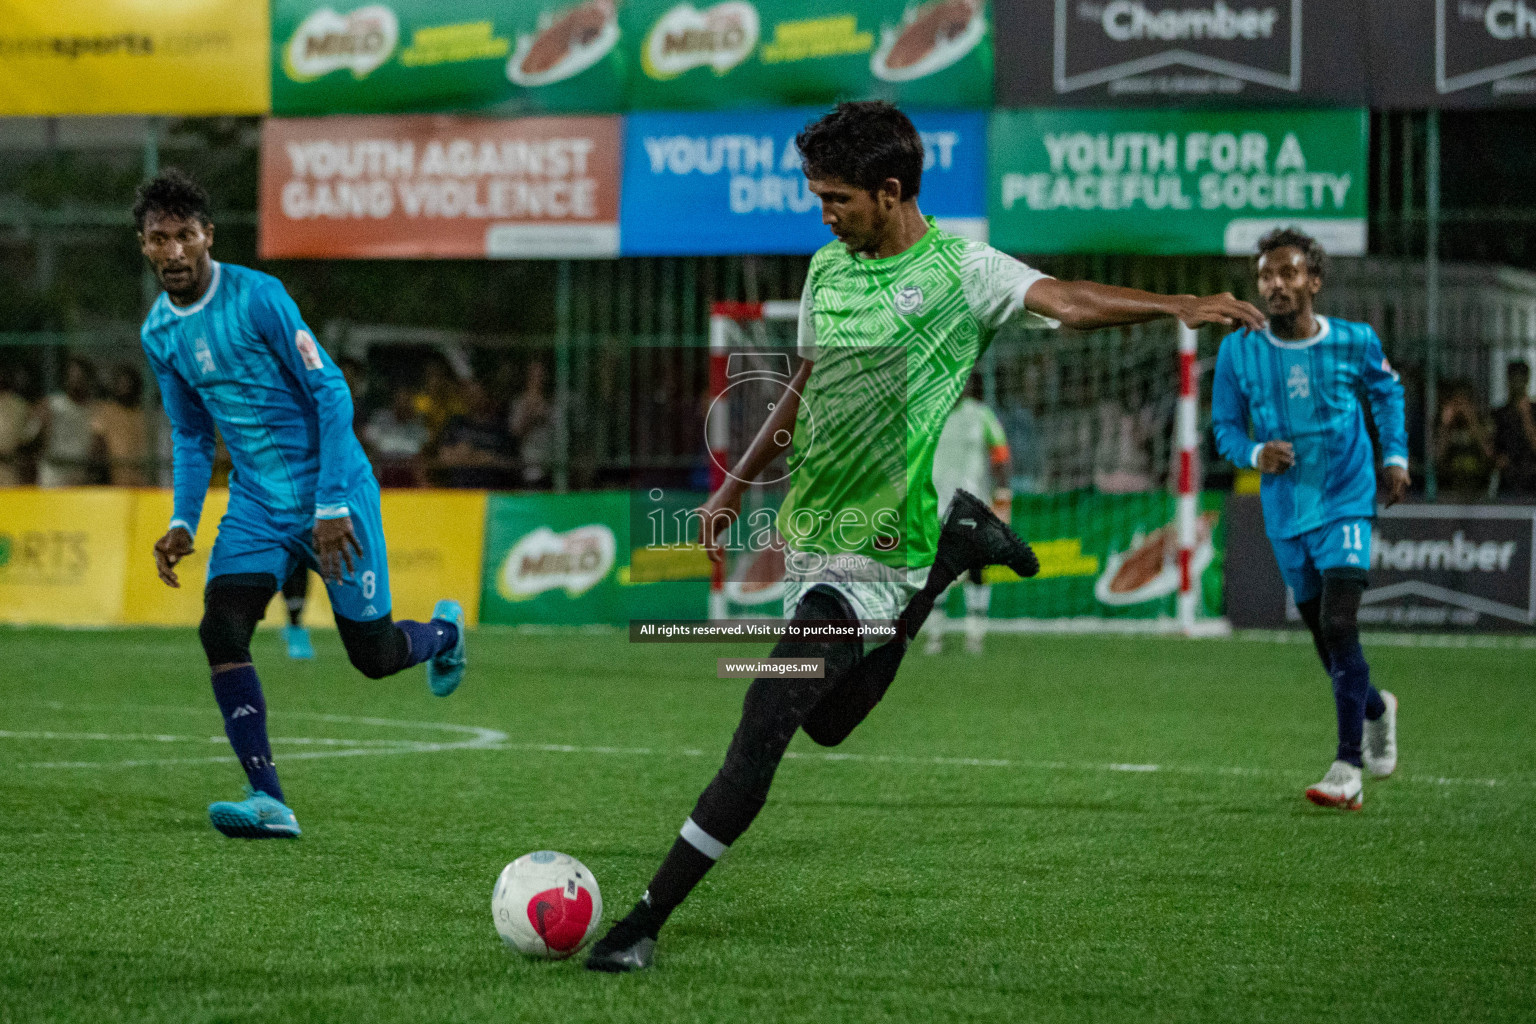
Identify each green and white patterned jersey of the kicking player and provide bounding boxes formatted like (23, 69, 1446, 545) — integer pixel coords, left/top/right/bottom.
(779, 218, 1060, 570)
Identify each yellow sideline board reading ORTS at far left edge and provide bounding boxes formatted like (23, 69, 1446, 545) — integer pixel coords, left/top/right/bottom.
(0, 487, 134, 626)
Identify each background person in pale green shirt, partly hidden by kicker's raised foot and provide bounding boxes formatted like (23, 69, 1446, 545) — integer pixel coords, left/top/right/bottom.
(923, 373, 1014, 654)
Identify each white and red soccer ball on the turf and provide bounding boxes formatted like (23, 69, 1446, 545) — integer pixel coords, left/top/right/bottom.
(490, 851, 602, 960)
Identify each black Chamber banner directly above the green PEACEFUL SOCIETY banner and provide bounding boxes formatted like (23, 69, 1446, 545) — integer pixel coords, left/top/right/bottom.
(997, 0, 1370, 107)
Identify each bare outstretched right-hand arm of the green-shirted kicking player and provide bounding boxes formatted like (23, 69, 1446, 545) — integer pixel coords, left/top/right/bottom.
(1025, 278, 1264, 330)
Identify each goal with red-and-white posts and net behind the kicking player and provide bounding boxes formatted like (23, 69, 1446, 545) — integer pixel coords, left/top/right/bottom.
(707, 302, 1223, 633)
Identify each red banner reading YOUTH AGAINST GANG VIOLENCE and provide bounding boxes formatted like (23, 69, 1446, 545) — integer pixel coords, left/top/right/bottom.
(260, 115, 619, 259)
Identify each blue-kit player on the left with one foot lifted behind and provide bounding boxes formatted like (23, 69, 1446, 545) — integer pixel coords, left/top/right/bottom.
(134, 170, 464, 838)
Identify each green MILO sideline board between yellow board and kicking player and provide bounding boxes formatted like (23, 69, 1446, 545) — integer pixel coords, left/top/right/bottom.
(479, 491, 710, 625)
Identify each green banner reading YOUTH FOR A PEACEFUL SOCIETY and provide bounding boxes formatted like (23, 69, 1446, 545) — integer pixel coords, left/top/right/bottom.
(988, 111, 1369, 256)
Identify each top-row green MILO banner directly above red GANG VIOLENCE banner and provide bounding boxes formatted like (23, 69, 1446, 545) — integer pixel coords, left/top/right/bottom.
(270, 0, 627, 115)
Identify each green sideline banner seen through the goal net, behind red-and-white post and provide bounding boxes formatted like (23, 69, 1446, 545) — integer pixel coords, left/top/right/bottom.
(948, 491, 1226, 619)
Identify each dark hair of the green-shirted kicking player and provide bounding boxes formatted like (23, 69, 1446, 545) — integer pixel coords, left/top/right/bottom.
(794, 100, 923, 200)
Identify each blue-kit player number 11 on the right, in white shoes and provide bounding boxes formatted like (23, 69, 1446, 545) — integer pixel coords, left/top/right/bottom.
(1212, 229, 1409, 811)
